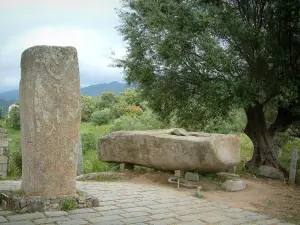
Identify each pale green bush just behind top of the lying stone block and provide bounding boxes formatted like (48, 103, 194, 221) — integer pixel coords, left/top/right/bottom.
(109, 111, 161, 132)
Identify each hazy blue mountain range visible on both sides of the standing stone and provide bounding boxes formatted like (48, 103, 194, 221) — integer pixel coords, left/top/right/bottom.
(0, 81, 129, 114)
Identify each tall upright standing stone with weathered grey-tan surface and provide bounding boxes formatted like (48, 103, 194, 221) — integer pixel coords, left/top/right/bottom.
(20, 46, 81, 196)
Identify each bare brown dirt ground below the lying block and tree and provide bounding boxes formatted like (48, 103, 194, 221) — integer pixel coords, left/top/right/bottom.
(110, 172, 300, 224)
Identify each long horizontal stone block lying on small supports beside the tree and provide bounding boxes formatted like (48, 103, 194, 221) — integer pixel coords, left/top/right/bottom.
(98, 130, 240, 172)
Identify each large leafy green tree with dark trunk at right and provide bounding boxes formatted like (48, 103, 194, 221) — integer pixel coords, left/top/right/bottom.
(116, 0, 300, 174)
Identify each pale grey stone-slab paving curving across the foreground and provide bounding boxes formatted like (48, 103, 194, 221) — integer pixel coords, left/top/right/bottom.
(0, 181, 290, 225)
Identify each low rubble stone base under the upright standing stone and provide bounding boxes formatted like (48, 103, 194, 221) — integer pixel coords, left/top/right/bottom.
(0, 191, 99, 213)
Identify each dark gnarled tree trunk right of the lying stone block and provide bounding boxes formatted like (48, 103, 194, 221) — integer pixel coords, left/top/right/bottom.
(245, 103, 288, 176)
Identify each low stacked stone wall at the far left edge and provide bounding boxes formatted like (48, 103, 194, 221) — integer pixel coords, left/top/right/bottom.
(0, 128, 8, 177)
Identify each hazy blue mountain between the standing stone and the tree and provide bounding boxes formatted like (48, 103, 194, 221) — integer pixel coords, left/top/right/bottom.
(81, 81, 129, 96)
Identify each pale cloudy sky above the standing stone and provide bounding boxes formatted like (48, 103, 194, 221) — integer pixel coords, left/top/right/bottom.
(0, 0, 125, 93)
